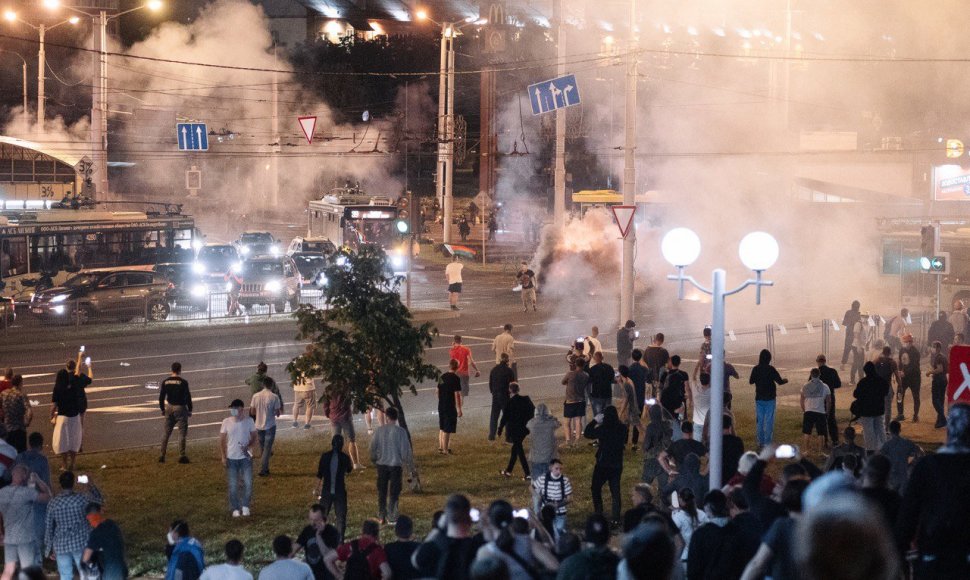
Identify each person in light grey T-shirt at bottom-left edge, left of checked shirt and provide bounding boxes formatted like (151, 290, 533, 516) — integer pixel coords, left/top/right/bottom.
(0, 464, 51, 579)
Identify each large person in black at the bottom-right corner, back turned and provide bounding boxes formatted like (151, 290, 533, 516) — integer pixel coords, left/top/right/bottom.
(896, 403, 970, 580)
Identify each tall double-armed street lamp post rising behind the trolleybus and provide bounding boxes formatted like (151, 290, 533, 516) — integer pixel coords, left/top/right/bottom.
(50, 0, 163, 197)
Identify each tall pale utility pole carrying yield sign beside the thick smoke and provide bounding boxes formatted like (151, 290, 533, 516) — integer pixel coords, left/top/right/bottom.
(619, 0, 637, 326)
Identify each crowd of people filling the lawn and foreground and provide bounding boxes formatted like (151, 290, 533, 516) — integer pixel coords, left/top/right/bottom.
(0, 305, 970, 580)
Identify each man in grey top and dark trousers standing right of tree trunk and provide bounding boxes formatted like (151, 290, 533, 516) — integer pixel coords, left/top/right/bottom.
(370, 407, 414, 523)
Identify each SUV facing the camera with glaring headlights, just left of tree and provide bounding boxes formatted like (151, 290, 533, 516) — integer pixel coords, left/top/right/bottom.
(228, 256, 303, 312)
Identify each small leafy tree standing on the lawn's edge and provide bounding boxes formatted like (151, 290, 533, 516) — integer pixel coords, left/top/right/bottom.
(286, 245, 440, 490)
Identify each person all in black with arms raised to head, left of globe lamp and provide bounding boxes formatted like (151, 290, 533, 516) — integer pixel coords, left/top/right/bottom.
(583, 405, 627, 527)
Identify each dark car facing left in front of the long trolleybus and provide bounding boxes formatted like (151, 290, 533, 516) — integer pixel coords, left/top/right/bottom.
(30, 266, 174, 323)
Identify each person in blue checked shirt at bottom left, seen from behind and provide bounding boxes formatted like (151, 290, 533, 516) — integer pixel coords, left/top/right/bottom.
(45, 471, 103, 578)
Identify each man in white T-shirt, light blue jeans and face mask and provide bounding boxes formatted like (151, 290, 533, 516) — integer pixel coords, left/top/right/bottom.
(219, 399, 256, 518)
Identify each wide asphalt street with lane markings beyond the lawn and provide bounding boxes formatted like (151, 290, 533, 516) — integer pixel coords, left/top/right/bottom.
(0, 270, 944, 454)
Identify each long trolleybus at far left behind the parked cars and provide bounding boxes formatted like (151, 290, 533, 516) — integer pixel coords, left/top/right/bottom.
(0, 200, 202, 303)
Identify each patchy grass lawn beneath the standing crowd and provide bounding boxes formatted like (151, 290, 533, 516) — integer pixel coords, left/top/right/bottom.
(64, 386, 932, 576)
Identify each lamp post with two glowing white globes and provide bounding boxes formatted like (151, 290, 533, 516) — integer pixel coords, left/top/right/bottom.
(660, 228, 778, 489)
